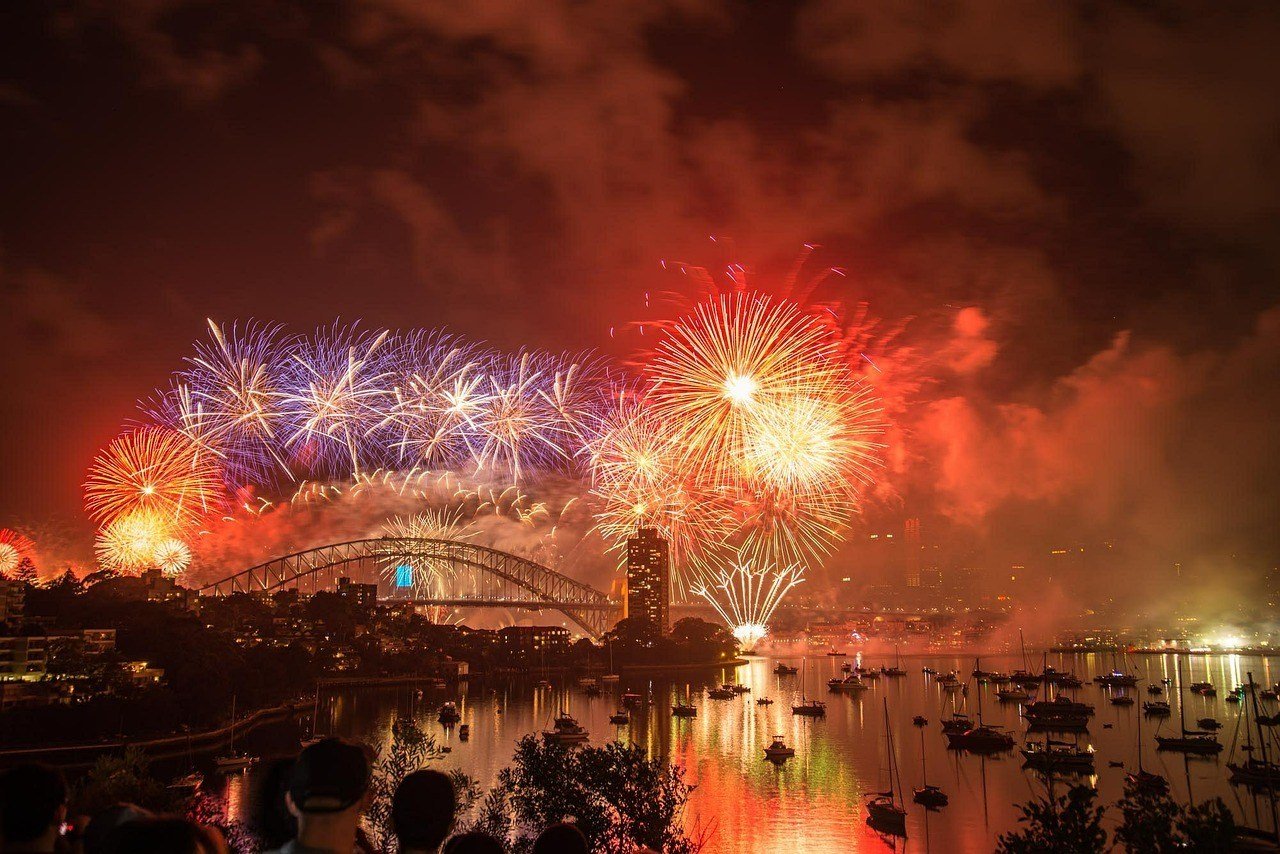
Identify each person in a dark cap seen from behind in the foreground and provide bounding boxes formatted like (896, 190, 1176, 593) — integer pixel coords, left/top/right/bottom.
(266, 739, 370, 854)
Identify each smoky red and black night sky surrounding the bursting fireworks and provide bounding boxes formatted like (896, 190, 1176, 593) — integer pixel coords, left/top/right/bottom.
(0, 0, 1280, 588)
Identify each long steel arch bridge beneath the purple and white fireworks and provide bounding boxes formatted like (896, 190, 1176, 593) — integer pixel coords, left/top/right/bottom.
(200, 536, 618, 639)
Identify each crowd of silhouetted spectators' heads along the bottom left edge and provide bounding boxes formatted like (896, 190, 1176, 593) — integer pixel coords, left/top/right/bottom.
(0, 739, 646, 854)
